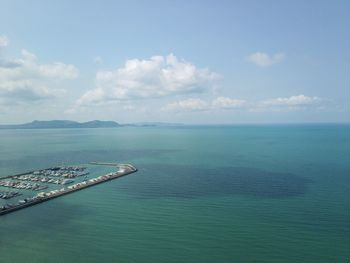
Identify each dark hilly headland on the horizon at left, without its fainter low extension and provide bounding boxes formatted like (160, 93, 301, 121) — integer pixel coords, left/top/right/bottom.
(0, 120, 122, 129)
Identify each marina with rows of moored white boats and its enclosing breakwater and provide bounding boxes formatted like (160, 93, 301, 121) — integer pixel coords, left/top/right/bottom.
(0, 162, 137, 216)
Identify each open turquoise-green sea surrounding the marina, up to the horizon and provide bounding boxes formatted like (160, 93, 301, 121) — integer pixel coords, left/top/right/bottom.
(0, 125, 350, 263)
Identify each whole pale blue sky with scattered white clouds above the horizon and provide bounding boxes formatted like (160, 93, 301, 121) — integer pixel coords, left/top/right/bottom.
(0, 0, 350, 124)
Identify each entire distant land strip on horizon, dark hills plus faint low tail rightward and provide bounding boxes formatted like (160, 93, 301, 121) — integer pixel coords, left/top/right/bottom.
(0, 120, 182, 129)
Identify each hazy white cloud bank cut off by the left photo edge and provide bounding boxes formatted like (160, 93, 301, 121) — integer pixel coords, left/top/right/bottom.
(0, 49, 78, 101)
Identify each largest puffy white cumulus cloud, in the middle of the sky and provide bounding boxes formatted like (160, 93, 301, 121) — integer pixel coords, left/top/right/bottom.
(77, 54, 219, 106)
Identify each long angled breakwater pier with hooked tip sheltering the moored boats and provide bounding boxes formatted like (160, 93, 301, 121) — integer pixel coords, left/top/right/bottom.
(0, 162, 137, 216)
